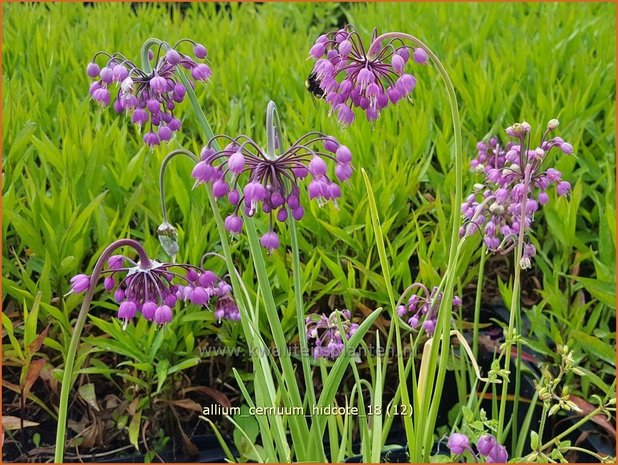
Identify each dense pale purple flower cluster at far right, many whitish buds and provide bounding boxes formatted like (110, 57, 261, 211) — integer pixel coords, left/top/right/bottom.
(459, 119, 573, 269)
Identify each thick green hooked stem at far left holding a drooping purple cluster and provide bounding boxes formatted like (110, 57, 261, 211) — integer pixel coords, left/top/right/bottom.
(54, 239, 151, 463)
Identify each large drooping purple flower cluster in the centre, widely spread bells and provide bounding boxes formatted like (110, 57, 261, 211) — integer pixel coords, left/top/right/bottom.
(192, 132, 352, 252)
